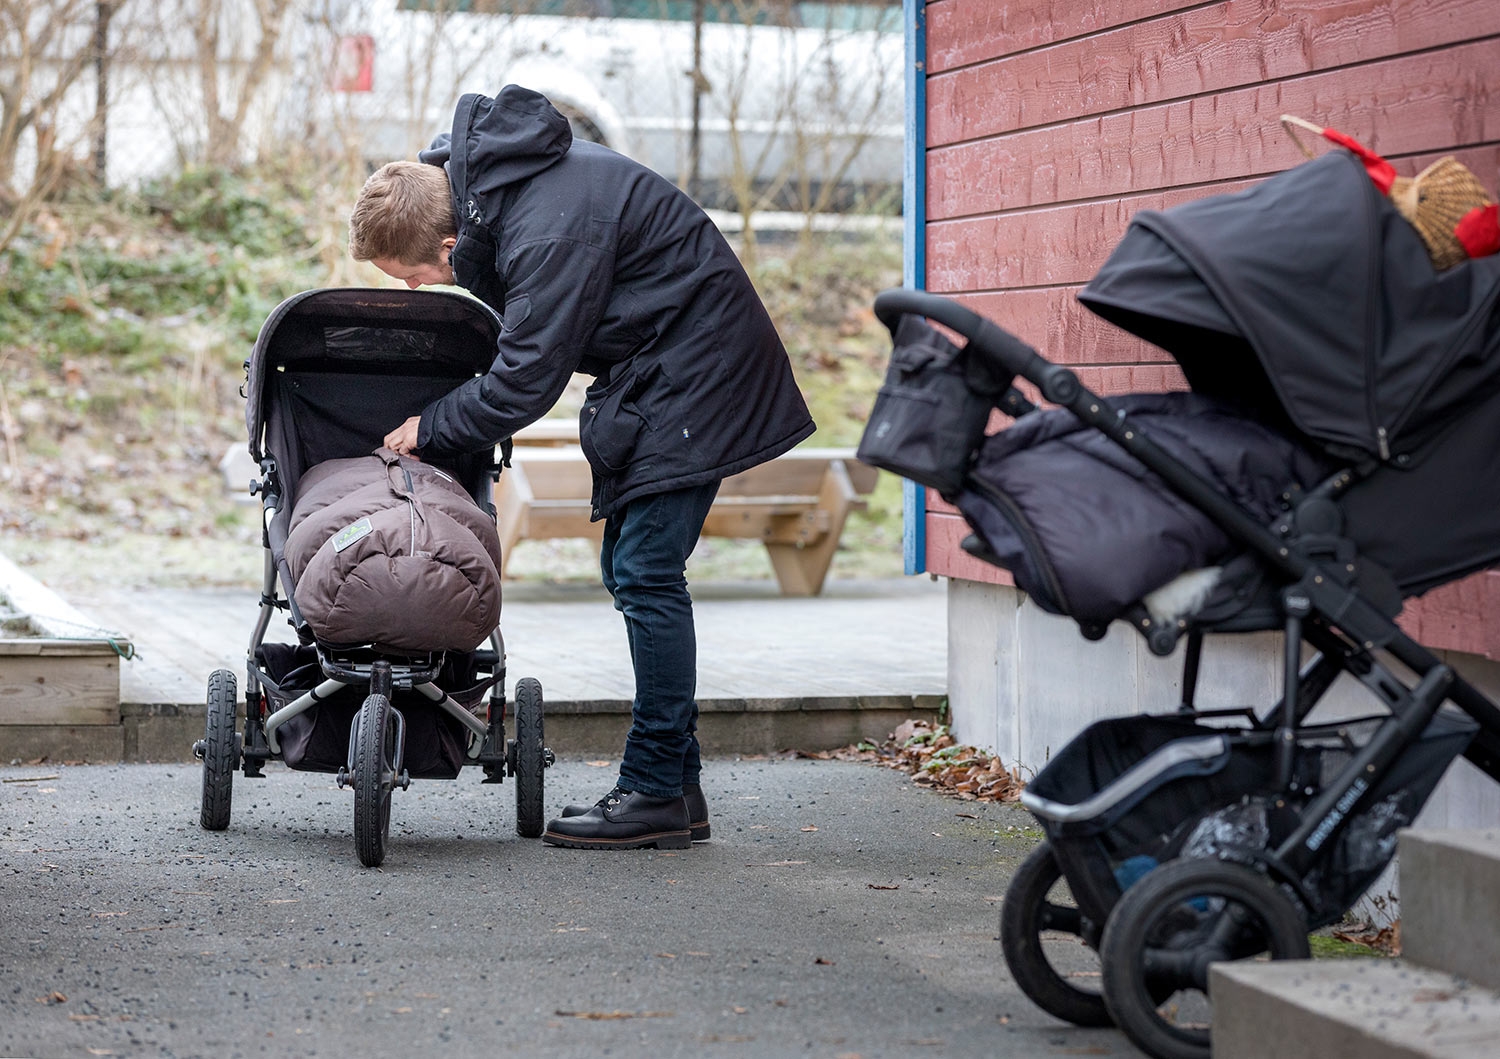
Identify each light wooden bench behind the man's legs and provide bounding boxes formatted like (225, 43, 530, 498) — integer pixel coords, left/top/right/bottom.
(495, 435, 878, 596)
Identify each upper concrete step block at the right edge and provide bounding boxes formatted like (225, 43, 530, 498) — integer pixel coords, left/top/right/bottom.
(1398, 830, 1500, 990)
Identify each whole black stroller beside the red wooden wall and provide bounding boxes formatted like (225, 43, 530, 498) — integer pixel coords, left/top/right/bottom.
(860, 152, 1500, 1059)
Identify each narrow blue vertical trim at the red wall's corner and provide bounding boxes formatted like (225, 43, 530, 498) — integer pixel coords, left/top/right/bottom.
(902, 0, 927, 575)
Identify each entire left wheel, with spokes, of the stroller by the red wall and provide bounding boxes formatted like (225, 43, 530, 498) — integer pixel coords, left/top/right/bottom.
(1001, 842, 1115, 1026)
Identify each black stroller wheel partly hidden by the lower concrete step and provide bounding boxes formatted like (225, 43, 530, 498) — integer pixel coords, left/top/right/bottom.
(1100, 858, 1310, 1059)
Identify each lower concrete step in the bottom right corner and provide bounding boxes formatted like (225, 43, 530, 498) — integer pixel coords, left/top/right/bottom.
(1209, 960, 1500, 1059)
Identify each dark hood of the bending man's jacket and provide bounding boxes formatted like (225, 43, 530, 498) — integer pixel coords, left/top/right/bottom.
(417, 84, 573, 213)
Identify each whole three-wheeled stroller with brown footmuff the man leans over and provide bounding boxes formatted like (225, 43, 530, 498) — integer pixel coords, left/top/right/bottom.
(195, 288, 552, 867)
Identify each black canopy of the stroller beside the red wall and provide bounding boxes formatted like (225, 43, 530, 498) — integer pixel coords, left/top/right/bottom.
(1079, 150, 1500, 459)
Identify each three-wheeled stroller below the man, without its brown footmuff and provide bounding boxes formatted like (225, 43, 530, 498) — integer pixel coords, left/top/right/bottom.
(194, 288, 552, 867)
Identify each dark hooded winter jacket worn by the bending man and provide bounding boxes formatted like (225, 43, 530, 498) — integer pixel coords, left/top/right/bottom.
(417, 86, 813, 519)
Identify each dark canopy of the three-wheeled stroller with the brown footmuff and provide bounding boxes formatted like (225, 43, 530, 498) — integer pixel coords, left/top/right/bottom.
(245, 287, 500, 462)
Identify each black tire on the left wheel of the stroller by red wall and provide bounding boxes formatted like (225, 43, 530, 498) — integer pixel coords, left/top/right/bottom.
(1001, 842, 1115, 1026)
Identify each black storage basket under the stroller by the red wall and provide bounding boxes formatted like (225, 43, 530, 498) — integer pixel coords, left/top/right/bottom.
(1022, 713, 1476, 929)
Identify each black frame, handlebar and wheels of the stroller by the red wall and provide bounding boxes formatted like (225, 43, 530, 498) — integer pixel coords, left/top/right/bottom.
(875, 290, 1500, 1059)
